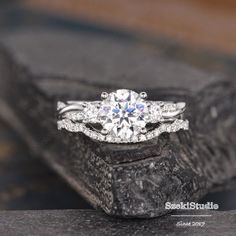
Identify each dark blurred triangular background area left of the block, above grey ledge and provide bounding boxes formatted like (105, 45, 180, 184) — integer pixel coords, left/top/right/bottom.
(0, 121, 91, 210)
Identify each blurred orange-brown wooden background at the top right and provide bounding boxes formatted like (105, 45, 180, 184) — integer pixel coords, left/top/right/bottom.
(23, 0, 236, 55)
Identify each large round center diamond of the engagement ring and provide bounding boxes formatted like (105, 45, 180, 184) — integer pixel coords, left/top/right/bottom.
(98, 89, 147, 139)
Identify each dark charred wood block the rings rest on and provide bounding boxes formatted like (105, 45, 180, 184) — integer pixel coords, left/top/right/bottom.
(0, 31, 236, 217)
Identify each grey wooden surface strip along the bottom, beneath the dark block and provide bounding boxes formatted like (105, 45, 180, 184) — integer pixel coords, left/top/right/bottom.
(0, 210, 236, 236)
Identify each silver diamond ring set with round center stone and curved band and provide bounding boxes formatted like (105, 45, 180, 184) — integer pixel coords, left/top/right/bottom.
(57, 89, 189, 143)
